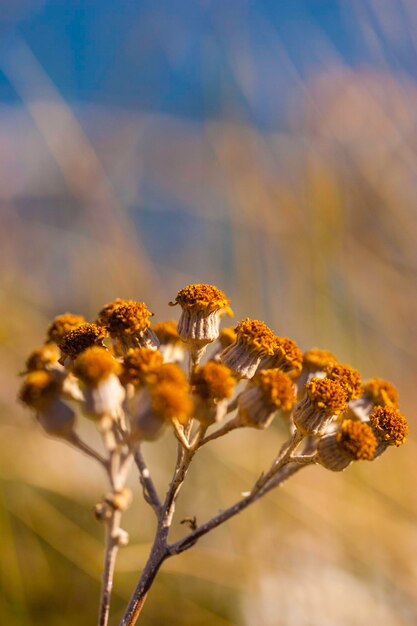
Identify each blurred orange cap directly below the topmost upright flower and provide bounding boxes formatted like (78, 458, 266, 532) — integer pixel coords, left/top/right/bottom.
(191, 361, 236, 400)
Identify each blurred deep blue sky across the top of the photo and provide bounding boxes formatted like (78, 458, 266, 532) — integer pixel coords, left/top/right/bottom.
(0, 0, 417, 127)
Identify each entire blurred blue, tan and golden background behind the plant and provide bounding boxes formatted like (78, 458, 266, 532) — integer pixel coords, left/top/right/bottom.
(0, 0, 417, 626)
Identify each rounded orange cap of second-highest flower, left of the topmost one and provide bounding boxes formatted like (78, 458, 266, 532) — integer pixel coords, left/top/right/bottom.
(106, 300, 153, 338)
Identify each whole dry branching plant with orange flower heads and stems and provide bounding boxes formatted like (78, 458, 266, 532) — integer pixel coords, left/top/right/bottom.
(20, 284, 408, 626)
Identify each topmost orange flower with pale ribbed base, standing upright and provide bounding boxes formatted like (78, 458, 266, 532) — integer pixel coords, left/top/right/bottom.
(169, 284, 229, 365)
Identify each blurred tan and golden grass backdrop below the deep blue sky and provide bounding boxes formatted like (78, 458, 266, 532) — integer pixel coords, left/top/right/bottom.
(0, 3, 417, 626)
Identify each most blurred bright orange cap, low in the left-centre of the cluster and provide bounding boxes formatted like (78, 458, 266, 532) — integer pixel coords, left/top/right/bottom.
(150, 382, 193, 424)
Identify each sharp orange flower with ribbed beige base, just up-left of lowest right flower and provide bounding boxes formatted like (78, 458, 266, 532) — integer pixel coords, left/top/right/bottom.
(293, 378, 347, 435)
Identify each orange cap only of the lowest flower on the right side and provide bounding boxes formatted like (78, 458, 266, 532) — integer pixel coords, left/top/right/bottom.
(336, 419, 377, 461)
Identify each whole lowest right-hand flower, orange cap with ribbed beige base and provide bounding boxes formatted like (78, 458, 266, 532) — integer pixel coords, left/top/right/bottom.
(317, 419, 377, 472)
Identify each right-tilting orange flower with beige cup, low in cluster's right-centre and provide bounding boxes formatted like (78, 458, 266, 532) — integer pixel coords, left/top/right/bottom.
(236, 369, 295, 428)
